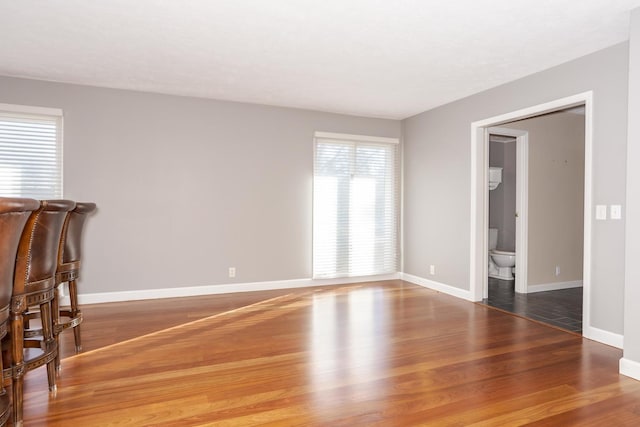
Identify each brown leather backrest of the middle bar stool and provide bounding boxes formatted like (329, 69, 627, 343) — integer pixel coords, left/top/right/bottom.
(13, 200, 75, 295)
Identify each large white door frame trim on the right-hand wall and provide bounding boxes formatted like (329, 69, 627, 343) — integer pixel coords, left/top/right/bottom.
(470, 92, 592, 337)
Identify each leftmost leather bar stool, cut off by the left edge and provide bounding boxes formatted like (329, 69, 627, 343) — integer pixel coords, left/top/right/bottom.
(0, 197, 40, 425)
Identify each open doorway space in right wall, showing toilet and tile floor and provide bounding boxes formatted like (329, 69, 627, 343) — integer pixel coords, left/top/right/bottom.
(483, 106, 584, 333)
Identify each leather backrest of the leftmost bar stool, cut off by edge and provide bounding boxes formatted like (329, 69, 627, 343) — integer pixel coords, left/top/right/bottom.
(0, 197, 40, 322)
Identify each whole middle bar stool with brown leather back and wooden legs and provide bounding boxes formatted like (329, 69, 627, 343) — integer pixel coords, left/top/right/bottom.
(10, 200, 75, 426)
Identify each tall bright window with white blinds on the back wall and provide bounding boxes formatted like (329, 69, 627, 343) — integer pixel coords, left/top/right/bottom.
(313, 132, 398, 278)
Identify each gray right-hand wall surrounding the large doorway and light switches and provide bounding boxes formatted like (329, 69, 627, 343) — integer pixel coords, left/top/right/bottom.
(403, 43, 628, 334)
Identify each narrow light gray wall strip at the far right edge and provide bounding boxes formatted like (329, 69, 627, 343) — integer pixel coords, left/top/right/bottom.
(624, 9, 640, 366)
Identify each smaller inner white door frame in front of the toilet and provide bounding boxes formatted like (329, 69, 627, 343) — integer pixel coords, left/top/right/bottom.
(482, 126, 529, 298)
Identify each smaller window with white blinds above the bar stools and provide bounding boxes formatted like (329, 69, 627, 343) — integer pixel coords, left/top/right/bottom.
(0, 104, 62, 199)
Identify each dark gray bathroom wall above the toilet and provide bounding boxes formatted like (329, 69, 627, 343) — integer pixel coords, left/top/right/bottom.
(489, 142, 516, 252)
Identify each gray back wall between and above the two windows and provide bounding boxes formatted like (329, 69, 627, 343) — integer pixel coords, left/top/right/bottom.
(0, 77, 401, 294)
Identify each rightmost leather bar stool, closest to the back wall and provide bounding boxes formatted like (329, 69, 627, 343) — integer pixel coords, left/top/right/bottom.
(53, 202, 96, 369)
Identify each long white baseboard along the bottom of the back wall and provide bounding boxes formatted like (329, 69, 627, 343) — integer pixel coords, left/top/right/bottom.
(61, 273, 400, 305)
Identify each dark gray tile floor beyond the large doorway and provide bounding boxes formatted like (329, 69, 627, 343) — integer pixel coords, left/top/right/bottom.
(482, 277, 582, 333)
